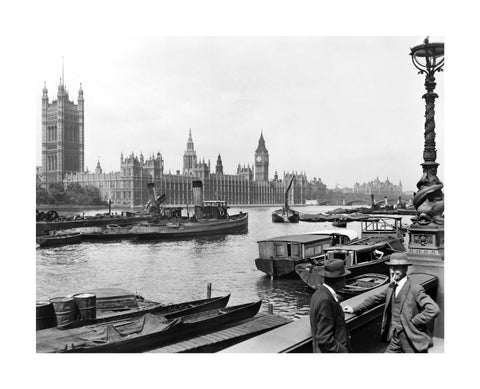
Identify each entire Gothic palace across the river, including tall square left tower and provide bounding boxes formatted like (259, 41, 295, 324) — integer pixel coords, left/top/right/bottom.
(37, 79, 402, 206)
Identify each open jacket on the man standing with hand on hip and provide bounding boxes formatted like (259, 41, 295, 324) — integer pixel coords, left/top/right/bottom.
(352, 276, 440, 352)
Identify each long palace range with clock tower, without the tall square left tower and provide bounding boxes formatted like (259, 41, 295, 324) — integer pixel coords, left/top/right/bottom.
(64, 131, 307, 206)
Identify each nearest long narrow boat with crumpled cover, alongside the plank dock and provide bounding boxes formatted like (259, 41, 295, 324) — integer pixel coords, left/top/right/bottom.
(36, 300, 262, 353)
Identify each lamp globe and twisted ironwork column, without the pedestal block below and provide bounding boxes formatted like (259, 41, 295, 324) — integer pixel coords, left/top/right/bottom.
(410, 37, 444, 226)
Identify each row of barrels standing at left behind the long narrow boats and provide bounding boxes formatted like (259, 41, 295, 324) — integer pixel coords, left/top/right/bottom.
(37, 293, 96, 331)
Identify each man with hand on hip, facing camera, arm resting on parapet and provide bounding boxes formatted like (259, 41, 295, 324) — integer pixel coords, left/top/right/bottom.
(343, 253, 440, 353)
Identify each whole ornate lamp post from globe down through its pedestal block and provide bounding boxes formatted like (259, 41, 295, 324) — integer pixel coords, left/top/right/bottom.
(409, 37, 444, 256)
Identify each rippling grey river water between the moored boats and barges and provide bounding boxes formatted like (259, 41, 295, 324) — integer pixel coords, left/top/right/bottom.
(36, 206, 411, 319)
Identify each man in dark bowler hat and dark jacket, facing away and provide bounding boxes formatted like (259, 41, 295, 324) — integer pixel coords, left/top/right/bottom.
(310, 259, 350, 353)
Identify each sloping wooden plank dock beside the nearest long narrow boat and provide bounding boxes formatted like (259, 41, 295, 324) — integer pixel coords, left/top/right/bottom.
(148, 314, 292, 353)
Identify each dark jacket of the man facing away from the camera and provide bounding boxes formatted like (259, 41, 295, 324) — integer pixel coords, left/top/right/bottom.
(310, 285, 350, 353)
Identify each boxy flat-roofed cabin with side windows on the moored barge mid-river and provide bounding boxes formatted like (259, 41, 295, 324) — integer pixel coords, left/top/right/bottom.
(257, 234, 332, 261)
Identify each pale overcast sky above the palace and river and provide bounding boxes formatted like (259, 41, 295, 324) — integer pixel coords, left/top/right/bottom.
(32, 36, 445, 190)
